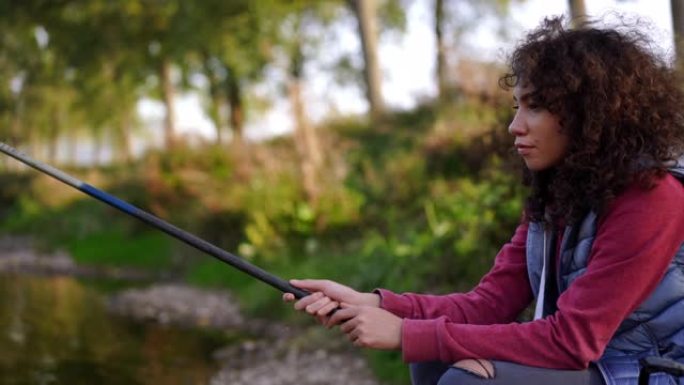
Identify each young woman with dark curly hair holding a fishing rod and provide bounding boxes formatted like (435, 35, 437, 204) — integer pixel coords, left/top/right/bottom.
(284, 18, 684, 385)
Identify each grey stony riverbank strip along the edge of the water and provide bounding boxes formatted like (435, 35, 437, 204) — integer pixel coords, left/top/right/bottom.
(0, 238, 379, 385)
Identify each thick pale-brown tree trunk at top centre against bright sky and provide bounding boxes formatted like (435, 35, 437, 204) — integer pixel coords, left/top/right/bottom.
(352, 0, 385, 122)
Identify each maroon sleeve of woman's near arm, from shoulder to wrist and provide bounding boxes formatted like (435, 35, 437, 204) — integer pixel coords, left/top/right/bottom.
(401, 176, 684, 369)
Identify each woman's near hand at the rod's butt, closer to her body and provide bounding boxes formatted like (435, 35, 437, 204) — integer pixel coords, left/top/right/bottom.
(327, 303, 402, 350)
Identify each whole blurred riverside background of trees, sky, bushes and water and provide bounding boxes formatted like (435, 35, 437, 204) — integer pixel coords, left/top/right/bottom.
(0, 0, 684, 384)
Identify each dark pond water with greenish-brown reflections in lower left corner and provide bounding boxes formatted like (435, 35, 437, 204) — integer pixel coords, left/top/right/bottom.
(0, 275, 221, 385)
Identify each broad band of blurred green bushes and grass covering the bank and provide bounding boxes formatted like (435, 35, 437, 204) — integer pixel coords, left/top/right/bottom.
(0, 96, 525, 384)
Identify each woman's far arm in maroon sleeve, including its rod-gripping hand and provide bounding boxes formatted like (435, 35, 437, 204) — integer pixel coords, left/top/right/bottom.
(283, 224, 532, 326)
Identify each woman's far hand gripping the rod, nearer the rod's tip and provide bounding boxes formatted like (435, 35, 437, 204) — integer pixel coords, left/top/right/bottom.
(283, 279, 380, 326)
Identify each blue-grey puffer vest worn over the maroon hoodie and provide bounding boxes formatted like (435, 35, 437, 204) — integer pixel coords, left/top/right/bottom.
(527, 158, 684, 385)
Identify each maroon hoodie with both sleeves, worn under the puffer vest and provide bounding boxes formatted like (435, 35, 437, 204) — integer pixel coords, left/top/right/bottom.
(378, 175, 684, 369)
